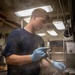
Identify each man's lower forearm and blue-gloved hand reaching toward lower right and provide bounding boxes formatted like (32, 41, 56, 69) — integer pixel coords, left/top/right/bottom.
(42, 58, 66, 71)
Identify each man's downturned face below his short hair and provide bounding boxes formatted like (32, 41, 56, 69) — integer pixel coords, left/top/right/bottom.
(34, 17, 46, 30)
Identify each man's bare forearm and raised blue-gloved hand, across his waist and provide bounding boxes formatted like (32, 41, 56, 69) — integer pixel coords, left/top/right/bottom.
(6, 47, 48, 65)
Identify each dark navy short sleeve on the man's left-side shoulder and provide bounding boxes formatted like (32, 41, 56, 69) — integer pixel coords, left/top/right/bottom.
(2, 30, 19, 57)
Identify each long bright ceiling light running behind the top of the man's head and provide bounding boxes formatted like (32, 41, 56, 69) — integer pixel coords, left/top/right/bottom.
(15, 5, 53, 17)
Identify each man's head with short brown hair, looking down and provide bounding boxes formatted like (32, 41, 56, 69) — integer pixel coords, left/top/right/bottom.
(31, 8, 49, 30)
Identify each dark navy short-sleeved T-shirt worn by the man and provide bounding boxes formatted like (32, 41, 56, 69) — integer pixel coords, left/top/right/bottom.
(3, 29, 44, 75)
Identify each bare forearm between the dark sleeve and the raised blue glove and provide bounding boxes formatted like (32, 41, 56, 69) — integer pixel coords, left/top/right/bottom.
(6, 54, 32, 65)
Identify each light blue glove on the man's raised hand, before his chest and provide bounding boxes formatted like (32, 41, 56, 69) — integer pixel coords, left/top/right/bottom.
(31, 47, 48, 61)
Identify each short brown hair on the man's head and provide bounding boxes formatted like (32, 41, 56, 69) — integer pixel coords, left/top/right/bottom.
(31, 8, 49, 20)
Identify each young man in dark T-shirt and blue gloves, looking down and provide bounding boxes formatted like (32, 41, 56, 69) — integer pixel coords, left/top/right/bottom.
(3, 8, 65, 75)
